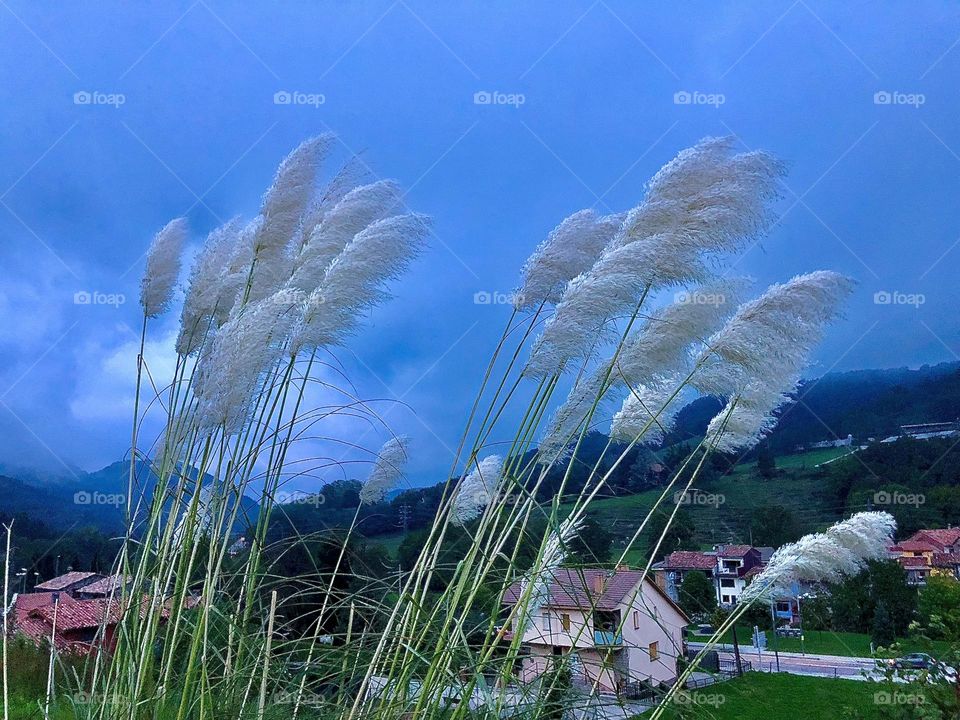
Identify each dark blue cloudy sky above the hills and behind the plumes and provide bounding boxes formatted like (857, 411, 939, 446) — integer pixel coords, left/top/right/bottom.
(0, 0, 960, 490)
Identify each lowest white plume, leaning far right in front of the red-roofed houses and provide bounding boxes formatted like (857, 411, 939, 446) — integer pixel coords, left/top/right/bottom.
(741, 512, 896, 602)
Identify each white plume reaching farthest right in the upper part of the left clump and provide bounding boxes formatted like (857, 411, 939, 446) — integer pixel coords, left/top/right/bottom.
(290, 213, 429, 355)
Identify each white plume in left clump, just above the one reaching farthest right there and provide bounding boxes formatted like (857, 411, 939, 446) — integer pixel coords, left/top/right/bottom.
(288, 180, 403, 292)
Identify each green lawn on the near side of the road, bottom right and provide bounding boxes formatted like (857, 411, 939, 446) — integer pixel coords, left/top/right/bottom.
(640, 673, 880, 720)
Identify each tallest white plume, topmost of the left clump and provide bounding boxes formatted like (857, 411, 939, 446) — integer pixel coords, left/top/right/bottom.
(247, 134, 333, 300)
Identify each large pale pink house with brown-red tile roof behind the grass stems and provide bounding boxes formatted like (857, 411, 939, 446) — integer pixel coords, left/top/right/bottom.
(504, 567, 690, 693)
